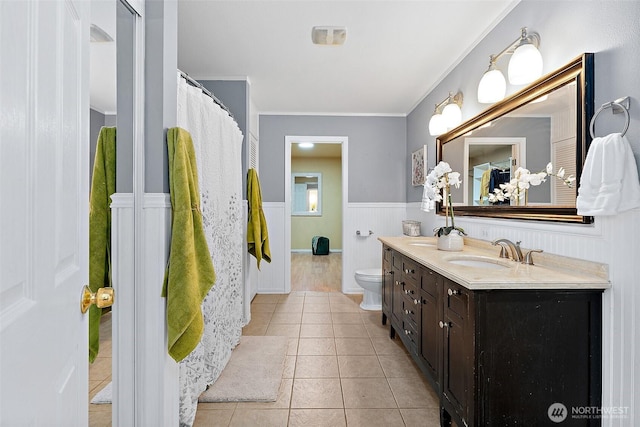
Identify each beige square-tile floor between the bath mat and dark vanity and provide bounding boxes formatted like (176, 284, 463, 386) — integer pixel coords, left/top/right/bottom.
(194, 291, 439, 427)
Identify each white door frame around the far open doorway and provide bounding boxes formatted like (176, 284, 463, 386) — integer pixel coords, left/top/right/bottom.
(283, 135, 349, 293)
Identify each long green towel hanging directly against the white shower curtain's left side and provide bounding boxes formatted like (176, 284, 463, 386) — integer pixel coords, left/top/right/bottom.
(162, 128, 216, 362)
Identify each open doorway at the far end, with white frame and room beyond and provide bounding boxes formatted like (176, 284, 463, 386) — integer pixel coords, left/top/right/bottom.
(284, 136, 348, 292)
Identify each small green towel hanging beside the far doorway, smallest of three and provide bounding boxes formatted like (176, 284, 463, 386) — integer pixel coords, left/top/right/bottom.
(247, 168, 271, 270)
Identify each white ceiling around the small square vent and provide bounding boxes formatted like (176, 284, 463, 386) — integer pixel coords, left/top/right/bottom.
(91, 0, 519, 115)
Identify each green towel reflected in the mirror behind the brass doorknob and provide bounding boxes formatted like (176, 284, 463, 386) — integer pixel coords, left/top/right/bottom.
(89, 127, 116, 363)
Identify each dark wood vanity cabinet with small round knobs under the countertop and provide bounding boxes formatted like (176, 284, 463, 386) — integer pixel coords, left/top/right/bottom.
(381, 244, 603, 427)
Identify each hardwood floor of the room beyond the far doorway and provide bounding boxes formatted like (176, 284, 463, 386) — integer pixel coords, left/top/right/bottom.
(291, 252, 342, 292)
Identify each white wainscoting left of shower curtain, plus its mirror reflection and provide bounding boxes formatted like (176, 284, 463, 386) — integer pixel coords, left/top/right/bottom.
(111, 193, 179, 427)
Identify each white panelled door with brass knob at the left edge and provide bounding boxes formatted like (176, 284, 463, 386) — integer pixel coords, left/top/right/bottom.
(0, 0, 89, 426)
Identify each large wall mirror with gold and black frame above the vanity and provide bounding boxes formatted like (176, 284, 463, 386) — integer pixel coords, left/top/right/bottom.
(436, 53, 594, 224)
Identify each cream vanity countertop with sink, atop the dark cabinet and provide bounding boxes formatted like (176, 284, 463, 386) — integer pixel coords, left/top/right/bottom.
(378, 236, 611, 290)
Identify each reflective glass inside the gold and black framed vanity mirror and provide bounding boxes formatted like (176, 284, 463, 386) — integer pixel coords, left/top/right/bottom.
(442, 83, 576, 207)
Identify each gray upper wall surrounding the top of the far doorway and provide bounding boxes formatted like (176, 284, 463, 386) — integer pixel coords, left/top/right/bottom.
(260, 115, 409, 203)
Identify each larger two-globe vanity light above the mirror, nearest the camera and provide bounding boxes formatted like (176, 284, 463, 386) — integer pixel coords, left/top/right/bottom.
(478, 27, 542, 104)
